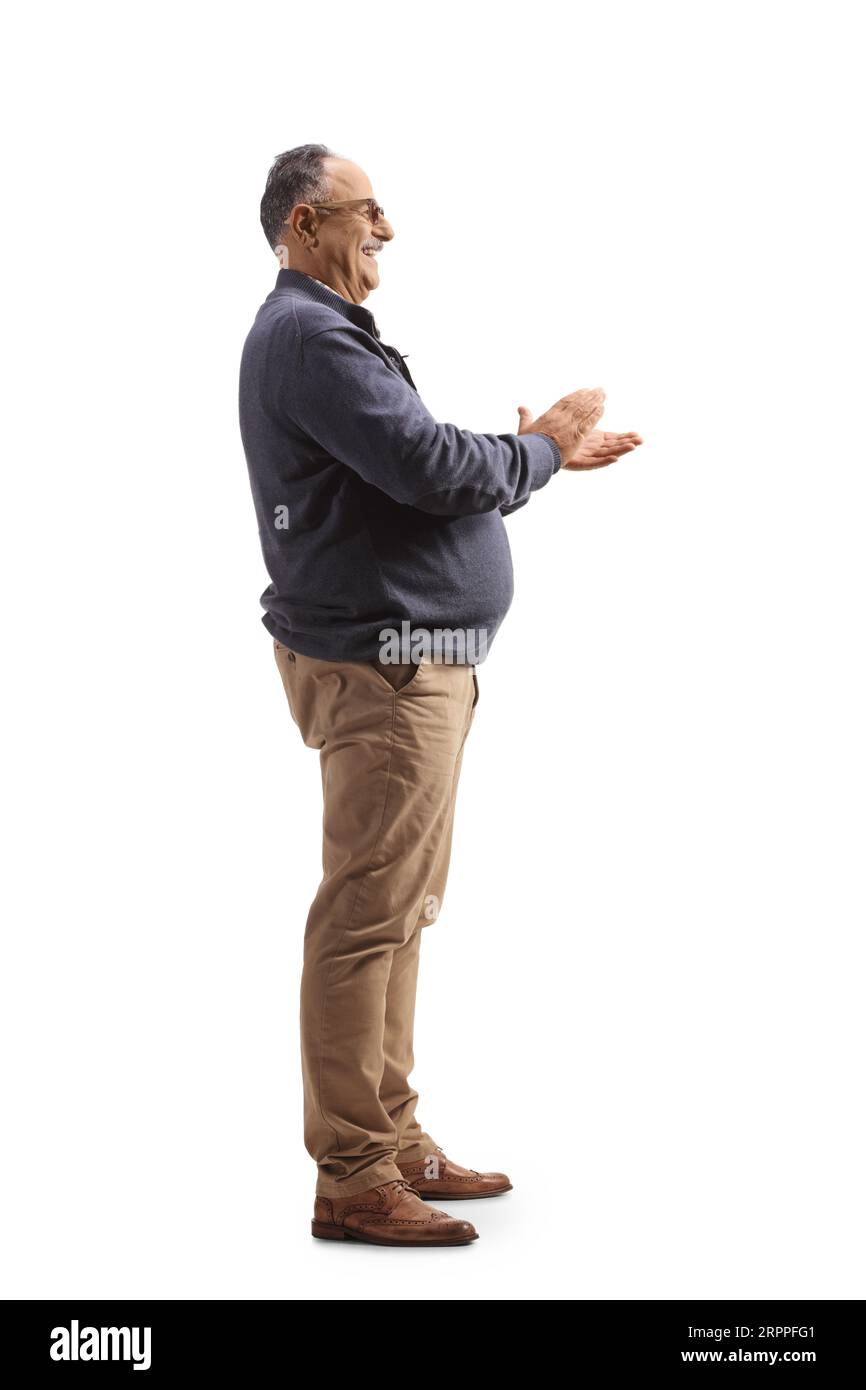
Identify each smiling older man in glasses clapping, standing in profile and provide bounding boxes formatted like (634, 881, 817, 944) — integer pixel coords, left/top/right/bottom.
(240, 145, 641, 1245)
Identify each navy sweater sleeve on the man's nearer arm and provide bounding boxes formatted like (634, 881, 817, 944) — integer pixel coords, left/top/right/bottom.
(291, 324, 562, 516)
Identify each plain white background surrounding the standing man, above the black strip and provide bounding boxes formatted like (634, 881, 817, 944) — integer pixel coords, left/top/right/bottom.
(0, 3, 866, 1300)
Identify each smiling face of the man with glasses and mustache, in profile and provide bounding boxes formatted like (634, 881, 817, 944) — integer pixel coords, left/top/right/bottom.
(292, 158, 393, 304)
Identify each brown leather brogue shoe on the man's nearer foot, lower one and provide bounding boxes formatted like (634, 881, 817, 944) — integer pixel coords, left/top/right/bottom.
(313, 1177, 478, 1245)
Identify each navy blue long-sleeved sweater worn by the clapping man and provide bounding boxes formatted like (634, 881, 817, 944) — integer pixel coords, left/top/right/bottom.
(240, 270, 560, 662)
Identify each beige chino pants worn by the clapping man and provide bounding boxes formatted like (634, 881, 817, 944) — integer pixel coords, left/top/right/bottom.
(274, 642, 478, 1197)
